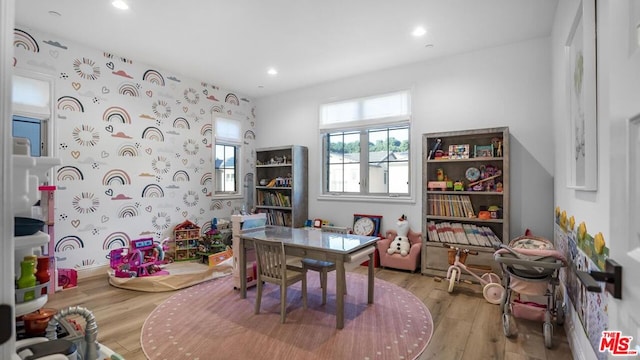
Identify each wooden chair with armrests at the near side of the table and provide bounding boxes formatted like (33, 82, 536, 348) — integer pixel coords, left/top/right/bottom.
(253, 239, 307, 324)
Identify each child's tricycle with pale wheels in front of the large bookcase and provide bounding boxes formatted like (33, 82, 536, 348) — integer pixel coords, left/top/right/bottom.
(444, 244, 505, 304)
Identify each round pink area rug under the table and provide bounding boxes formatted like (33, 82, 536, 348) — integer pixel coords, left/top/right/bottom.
(140, 272, 433, 360)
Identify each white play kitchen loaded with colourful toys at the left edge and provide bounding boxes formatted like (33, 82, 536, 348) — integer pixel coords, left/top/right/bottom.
(0, 137, 123, 360)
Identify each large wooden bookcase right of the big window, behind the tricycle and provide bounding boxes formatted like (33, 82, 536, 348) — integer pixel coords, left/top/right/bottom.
(422, 127, 509, 280)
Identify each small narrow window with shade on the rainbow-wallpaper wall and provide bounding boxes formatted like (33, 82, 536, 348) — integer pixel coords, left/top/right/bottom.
(213, 117, 242, 196)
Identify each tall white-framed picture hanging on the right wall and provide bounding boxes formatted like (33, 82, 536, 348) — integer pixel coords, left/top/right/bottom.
(565, 0, 598, 191)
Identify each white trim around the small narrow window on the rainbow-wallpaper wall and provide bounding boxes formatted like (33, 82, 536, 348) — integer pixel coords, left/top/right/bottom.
(211, 113, 244, 200)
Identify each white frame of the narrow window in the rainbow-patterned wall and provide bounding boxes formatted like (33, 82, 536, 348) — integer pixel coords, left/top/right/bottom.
(211, 113, 244, 199)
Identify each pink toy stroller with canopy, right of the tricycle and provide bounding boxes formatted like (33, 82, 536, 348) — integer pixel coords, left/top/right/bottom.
(494, 235, 566, 348)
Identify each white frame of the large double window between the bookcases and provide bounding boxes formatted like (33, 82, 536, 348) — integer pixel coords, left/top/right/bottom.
(318, 91, 416, 203)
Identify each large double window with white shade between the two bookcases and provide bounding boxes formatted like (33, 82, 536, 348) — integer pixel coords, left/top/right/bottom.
(320, 91, 410, 197)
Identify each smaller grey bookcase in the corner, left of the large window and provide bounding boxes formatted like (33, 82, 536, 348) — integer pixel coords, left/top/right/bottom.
(255, 145, 309, 227)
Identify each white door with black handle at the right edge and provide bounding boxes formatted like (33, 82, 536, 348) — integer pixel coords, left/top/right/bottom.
(599, 0, 640, 352)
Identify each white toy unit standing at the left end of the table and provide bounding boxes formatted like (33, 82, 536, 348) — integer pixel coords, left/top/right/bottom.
(231, 213, 267, 289)
